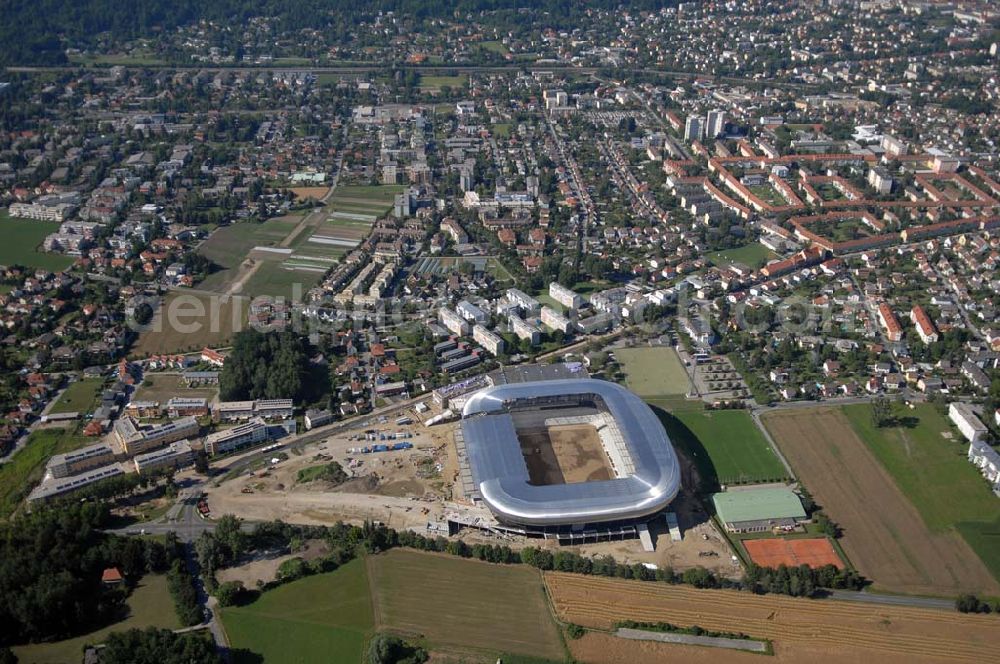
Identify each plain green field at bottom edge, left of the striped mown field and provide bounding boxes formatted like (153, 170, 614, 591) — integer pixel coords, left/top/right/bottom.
(222, 560, 375, 664)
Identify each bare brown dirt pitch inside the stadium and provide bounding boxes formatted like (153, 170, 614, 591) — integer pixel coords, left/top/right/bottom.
(517, 425, 611, 486)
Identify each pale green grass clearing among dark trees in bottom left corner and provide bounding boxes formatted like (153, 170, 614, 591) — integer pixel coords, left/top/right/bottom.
(12, 574, 181, 664)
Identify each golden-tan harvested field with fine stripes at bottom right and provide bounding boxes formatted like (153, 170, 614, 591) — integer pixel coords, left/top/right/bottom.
(545, 572, 1000, 663)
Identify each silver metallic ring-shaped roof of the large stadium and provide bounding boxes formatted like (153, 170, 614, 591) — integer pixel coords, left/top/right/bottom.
(462, 378, 680, 526)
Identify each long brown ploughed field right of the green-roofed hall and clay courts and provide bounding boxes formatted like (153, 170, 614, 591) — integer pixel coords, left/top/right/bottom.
(764, 408, 1000, 592)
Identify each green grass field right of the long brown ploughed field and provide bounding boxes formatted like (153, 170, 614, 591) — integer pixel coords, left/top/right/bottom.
(844, 404, 1000, 581)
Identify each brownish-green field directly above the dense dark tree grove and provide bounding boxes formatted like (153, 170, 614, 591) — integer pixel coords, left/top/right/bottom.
(132, 291, 250, 357)
